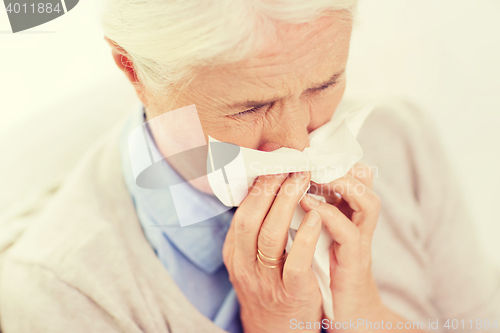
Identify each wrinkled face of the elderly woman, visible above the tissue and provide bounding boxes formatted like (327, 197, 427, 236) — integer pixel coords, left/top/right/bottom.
(148, 14, 352, 193)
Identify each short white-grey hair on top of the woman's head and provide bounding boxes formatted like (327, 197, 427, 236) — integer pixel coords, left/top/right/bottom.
(101, 0, 358, 95)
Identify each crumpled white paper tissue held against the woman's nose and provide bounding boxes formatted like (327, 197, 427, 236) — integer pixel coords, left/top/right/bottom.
(207, 103, 375, 320)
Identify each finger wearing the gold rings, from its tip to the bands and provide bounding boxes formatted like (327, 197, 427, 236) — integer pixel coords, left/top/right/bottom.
(258, 172, 310, 258)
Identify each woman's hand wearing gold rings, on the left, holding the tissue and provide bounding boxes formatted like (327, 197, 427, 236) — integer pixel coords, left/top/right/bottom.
(223, 172, 322, 333)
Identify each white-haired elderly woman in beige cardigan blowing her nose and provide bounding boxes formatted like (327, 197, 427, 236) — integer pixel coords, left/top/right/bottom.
(0, 0, 500, 333)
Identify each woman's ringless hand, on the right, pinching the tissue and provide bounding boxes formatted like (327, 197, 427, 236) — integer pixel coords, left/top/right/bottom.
(301, 164, 384, 332)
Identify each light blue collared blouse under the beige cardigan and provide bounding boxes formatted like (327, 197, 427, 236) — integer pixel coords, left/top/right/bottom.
(120, 105, 243, 333)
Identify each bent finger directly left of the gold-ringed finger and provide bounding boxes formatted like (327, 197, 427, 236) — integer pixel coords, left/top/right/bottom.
(231, 174, 288, 262)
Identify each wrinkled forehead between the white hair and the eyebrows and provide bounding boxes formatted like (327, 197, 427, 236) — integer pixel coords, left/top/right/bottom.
(187, 13, 352, 100)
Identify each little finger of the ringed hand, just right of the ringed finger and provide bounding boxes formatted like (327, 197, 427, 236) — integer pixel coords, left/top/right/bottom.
(283, 210, 321, 291)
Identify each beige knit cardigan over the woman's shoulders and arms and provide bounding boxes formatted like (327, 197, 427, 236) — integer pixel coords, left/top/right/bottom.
(0, 98, 500, 333)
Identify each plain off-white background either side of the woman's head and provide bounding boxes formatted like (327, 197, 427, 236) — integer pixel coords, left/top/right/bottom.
(0, 0, 500, 262)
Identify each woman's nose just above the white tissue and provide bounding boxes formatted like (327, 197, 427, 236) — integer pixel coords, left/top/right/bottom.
(259, 99, 311, 151)
